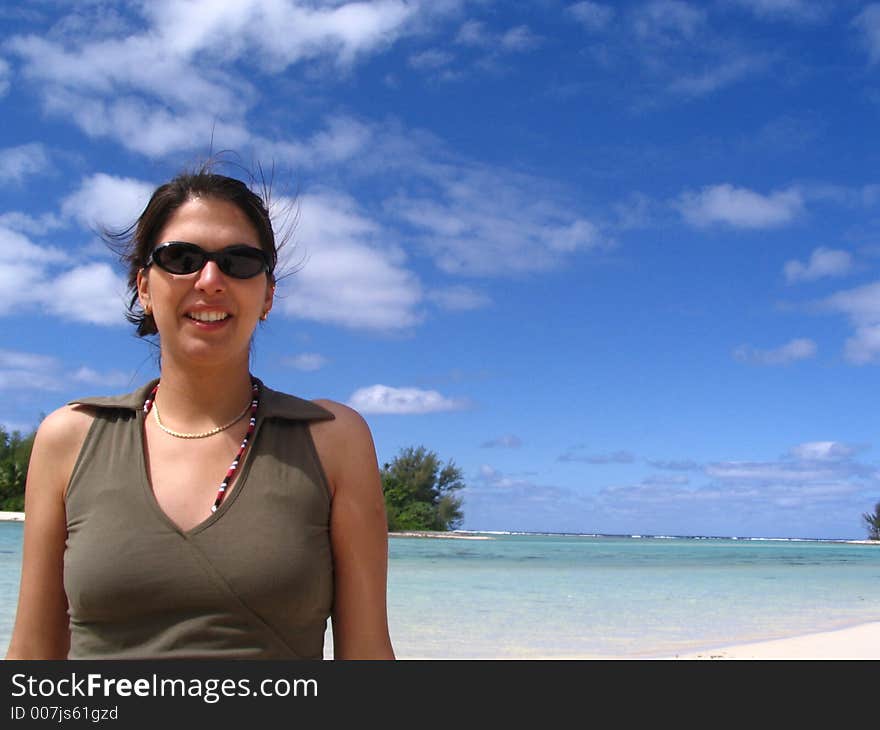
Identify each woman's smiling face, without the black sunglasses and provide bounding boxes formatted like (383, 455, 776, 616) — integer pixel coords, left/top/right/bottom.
(138, 197, 275, 365)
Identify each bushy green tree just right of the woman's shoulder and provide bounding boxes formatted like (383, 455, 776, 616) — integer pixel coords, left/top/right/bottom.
(381, 446, 465, 532)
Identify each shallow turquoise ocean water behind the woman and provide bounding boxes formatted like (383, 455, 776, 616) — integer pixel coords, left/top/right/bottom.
(0, 522, 880, 659)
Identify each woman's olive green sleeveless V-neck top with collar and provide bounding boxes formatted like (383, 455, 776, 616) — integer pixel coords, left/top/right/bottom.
(64, 380, 333, 659)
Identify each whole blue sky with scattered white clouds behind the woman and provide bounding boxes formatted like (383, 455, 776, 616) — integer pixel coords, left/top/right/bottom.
(0, 0, 880, 538)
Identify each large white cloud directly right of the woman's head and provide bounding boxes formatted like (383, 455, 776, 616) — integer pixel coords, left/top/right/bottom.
(276, 192, 422, 330)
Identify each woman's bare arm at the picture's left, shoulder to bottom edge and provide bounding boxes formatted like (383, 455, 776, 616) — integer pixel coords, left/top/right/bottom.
(6, 406, 91, 659)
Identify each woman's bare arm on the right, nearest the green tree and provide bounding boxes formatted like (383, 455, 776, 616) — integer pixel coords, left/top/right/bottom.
(311, 401, 394, 659)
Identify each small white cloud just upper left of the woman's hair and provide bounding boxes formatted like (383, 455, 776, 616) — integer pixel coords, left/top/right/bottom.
(61, 172, 155, 230)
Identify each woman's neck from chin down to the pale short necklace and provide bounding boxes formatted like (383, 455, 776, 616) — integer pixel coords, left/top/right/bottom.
(156, 358, 251, 431)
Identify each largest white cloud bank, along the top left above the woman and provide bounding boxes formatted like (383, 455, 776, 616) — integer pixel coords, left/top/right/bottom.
(6, 0, 444, 156)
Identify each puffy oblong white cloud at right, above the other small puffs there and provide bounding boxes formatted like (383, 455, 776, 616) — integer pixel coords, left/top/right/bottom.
(677, 183, 803, 228)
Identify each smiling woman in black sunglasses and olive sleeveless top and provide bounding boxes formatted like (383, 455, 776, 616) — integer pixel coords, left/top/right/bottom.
(7, 167, 394, 659)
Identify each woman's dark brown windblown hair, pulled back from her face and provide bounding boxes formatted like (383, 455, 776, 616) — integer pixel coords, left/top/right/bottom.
(101, 161, 280, 337)
